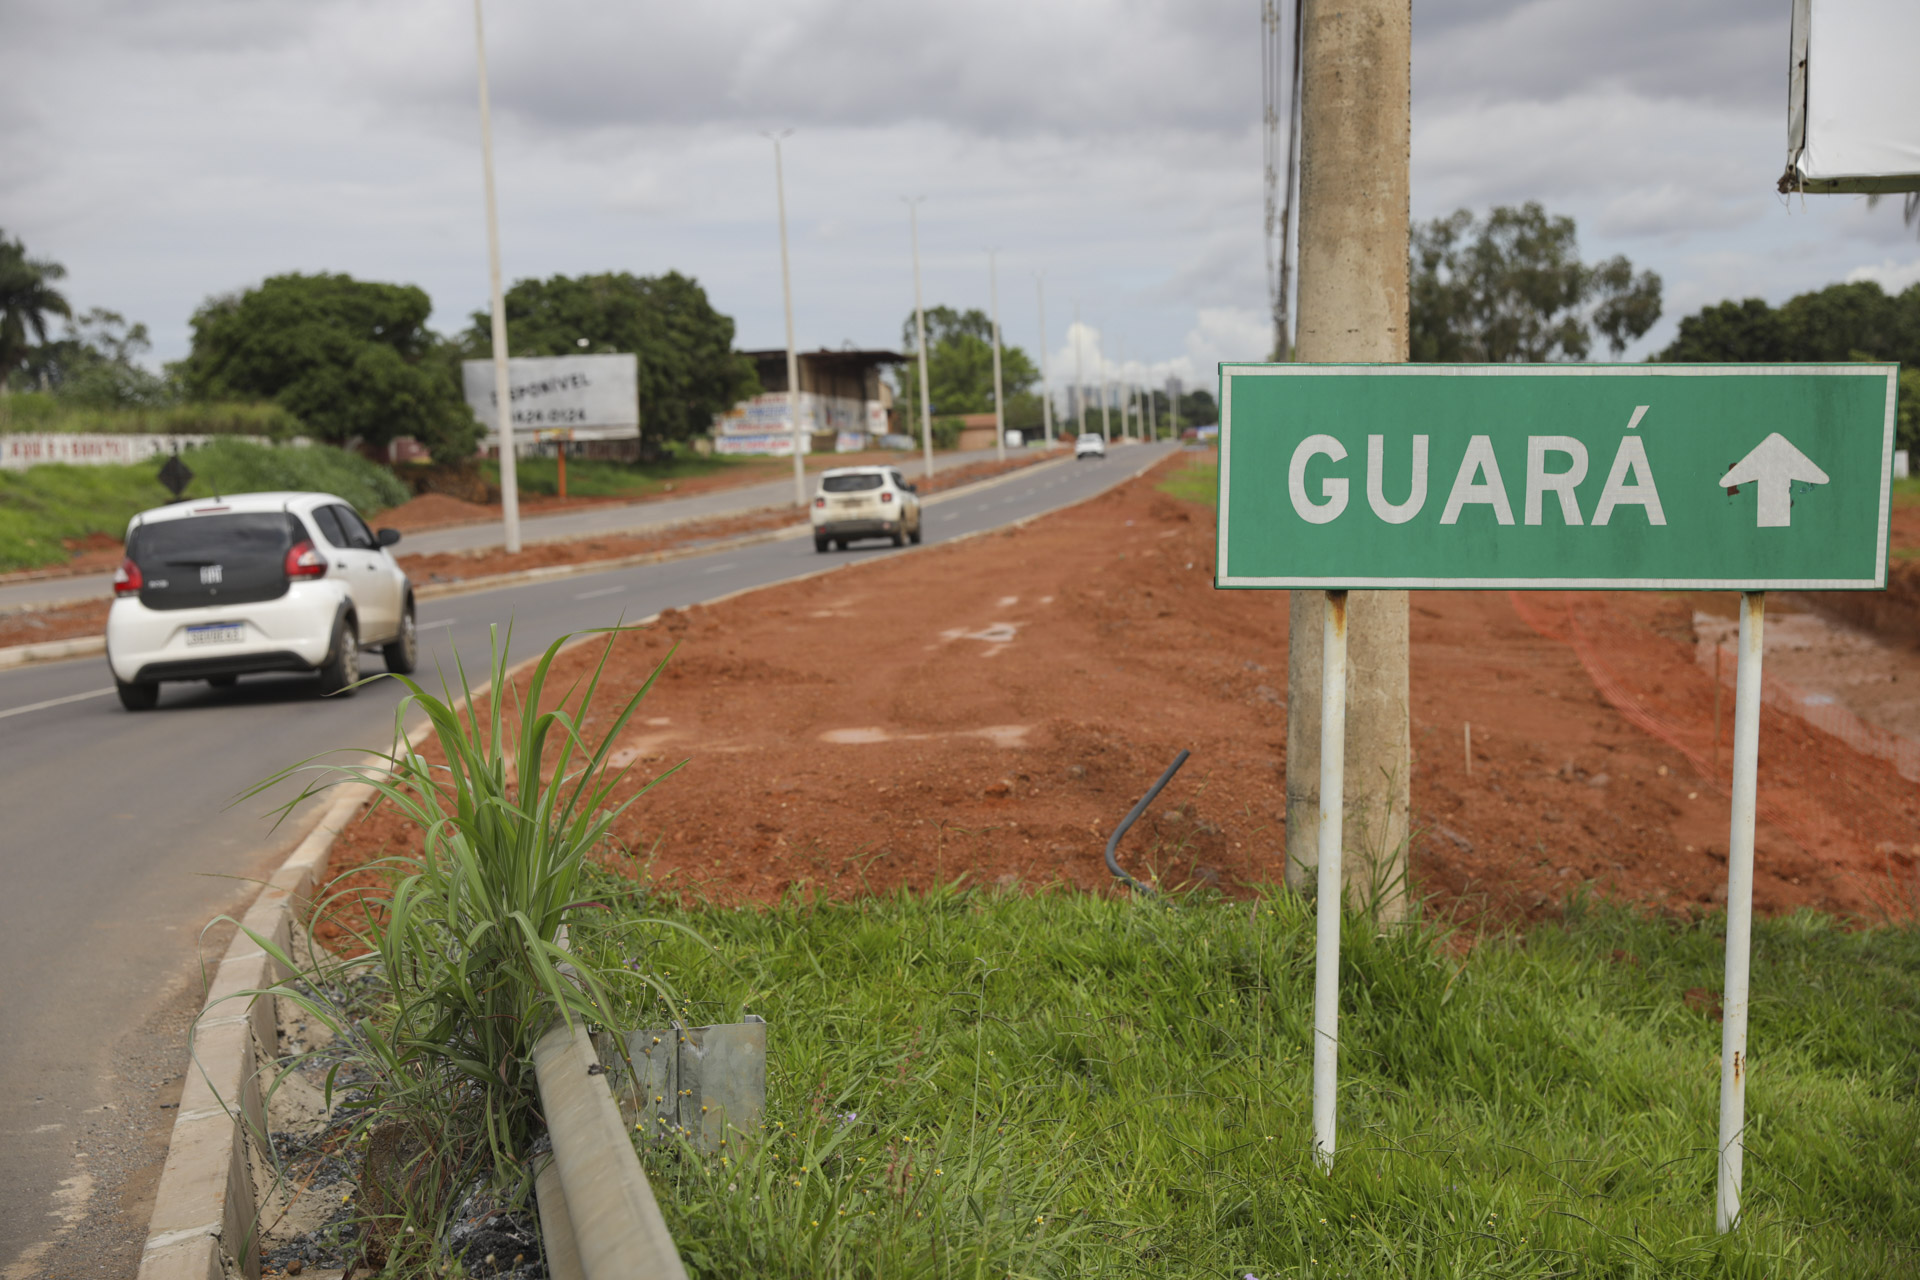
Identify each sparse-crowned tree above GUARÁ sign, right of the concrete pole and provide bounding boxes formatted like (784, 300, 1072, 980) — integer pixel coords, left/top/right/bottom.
(1407, 201, 1661, 363)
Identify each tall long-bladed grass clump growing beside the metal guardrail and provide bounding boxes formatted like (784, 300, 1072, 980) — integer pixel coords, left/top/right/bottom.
(216, 635, 687, 1274)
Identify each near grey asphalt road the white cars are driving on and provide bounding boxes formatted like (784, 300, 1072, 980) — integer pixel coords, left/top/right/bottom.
(0, 445, 1175, 1280)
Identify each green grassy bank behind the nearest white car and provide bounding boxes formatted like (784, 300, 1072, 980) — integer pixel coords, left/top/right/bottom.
(0, 439, 407, 570)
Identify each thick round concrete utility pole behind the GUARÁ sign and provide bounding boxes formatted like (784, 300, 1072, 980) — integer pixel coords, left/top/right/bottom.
(1286, 0, 1413, 919)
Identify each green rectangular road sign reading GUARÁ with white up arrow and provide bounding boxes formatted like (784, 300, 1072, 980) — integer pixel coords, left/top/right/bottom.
(1215, 365, 1899, 591)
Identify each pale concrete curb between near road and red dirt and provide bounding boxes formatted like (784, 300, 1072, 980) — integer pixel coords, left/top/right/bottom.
(139, 443, 1158, 1280)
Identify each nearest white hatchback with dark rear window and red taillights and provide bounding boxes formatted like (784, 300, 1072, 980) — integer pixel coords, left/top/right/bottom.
(108, 493, 420, 712)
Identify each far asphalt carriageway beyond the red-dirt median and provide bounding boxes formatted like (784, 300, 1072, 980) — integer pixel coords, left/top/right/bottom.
(0, 449, 995, 612)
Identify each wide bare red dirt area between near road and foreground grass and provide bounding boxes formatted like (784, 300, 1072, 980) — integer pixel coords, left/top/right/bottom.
(318, 459, 1920, 940)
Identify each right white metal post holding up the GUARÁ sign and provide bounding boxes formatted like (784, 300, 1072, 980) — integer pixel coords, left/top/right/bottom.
(1713, 591, 1766, 1234)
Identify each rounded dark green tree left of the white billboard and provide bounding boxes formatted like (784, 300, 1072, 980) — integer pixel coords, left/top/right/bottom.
(177, 274, 480, 461)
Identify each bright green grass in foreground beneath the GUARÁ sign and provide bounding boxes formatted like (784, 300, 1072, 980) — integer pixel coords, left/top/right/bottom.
(574, 879, 1920, 1280)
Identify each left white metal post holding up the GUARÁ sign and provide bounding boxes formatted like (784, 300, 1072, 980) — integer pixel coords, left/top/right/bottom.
(1313, 591, 1346, 1173)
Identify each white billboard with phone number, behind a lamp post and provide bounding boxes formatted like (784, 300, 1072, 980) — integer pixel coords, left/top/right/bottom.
(461, 351, 639, 445)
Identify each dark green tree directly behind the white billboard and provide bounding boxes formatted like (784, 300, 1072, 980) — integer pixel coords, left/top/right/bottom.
(461, 271, 760, 443)
